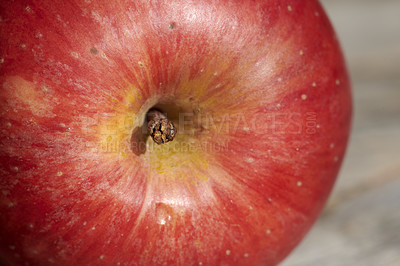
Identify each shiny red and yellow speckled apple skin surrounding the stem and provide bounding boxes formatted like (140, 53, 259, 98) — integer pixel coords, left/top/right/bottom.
(0, 0, 352, 265)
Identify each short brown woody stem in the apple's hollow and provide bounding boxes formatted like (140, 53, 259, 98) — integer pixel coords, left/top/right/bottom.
(147, 108, 177, 145)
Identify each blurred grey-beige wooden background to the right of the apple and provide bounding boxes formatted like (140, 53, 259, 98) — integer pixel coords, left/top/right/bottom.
(281, 0, 400, 266)
